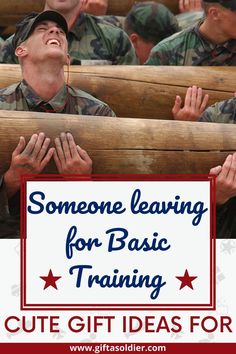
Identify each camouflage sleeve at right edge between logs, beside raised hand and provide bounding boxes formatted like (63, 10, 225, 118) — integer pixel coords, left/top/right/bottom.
(199, 98, 236, 123)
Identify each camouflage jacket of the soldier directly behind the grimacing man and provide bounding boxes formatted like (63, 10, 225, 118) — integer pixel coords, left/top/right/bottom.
(0, 13, 138, 65)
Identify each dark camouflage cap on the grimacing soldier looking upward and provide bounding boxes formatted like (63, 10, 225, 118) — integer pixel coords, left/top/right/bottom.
(12, 11, 68, 49)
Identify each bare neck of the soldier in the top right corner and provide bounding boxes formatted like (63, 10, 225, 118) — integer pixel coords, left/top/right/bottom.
(199, 18, 230, 44)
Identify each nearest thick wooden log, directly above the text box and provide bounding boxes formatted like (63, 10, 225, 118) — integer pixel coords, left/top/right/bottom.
(0, 111, 236, 174)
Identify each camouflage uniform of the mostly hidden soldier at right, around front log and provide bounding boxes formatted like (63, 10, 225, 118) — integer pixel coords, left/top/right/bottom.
(200, 98, 236, 238)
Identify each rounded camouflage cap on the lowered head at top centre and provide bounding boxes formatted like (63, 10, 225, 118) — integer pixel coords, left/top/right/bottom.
(125, 1, 179, 44)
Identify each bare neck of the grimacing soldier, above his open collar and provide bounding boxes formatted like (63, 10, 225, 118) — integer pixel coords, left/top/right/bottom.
(23, 68, 65, 102)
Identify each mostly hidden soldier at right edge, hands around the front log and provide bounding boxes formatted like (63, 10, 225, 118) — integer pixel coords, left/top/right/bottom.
(172, 86, 236, 238)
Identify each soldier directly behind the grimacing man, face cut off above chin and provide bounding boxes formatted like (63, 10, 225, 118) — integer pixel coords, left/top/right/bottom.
(0, 0, 138, 65)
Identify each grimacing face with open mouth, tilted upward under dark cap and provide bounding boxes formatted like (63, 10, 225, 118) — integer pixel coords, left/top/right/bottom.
(25, 21, 68, 64)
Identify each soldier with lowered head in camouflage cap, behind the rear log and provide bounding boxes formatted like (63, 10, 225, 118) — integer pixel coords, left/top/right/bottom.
(124, 1, 179, 64)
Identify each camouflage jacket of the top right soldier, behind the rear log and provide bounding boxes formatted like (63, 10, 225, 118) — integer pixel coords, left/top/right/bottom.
(145, 22, 236, 66)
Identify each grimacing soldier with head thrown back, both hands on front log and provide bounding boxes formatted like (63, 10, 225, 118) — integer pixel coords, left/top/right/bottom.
(0, 11, 114, 238)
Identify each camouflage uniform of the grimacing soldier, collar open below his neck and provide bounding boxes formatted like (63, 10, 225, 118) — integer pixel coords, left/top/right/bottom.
(0, 81, 115, 238)
